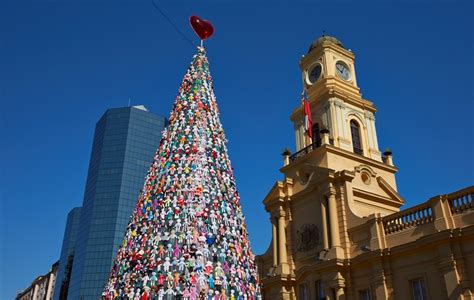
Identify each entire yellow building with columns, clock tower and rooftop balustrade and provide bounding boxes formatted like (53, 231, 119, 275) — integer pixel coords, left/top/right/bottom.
(257, 36, 474, 300)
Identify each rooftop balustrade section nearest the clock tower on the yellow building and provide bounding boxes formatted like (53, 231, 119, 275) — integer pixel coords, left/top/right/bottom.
(383, 202, 434, 234)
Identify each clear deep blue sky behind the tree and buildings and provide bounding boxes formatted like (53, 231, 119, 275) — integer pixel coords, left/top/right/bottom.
(0, 0, 474, 299)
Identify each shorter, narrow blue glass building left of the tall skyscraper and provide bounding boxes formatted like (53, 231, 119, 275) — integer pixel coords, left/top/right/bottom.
(53, 207, 81, 300)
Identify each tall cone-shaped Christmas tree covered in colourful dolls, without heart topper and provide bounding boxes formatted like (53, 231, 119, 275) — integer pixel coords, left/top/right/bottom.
(103, 47, 260, 300)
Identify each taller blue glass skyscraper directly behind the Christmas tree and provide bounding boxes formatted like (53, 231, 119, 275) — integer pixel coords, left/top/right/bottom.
(68, 105, 166, 300)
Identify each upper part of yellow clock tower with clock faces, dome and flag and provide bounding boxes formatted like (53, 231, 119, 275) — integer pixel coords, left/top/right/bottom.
(291, 36, 382, 162)
